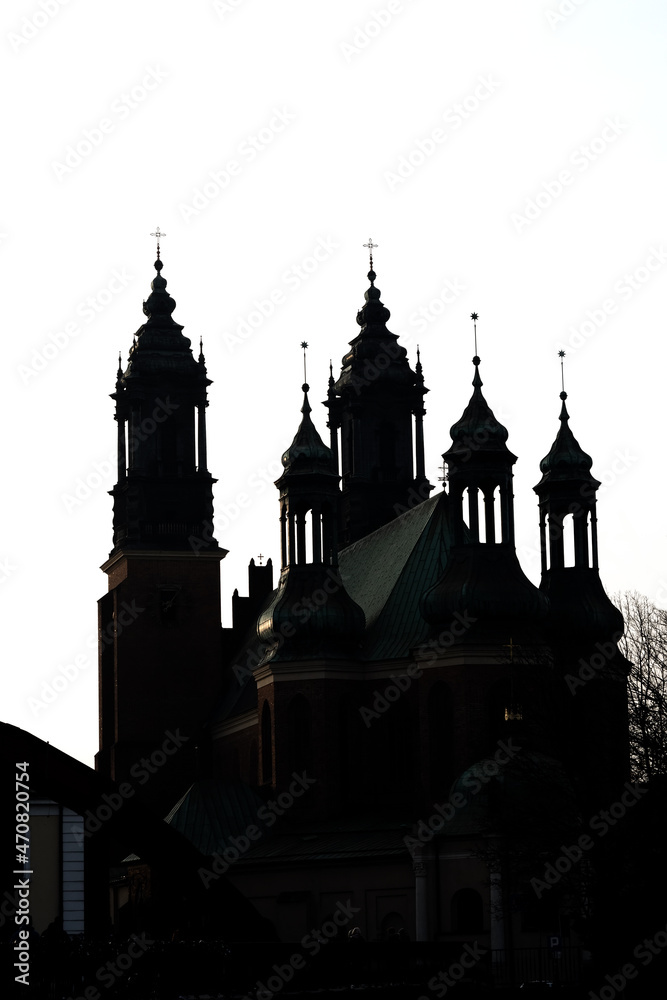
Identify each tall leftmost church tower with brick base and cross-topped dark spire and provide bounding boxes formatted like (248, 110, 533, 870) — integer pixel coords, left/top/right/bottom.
(97, 231, 226, 805)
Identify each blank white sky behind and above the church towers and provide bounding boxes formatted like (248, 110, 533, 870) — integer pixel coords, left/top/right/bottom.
(0, 0, 667, 763)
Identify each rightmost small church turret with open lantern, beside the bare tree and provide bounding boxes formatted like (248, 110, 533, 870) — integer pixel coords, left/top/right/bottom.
(534, 353, 630, 809)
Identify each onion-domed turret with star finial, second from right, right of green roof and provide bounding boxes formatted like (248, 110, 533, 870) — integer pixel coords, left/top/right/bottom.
(421, 313, 550, 773)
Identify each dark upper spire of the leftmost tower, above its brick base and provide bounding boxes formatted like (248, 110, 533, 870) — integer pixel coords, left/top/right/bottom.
(107, 237, 218, 553)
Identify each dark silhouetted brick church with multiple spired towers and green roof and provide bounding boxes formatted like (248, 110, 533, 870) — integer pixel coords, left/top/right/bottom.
(97, 242, 630, 976)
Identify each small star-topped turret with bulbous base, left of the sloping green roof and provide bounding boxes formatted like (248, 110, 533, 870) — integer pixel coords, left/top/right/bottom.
(254, 372, 365, 812)
